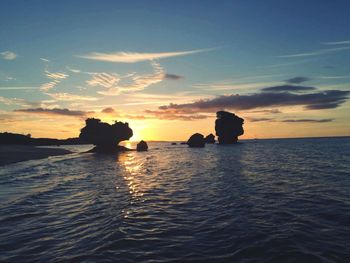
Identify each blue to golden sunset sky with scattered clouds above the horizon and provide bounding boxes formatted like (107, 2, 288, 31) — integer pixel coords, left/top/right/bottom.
(0, 0, 350, 140)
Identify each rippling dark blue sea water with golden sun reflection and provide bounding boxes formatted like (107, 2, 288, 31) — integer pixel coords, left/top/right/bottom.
(0, 138, 350, 262)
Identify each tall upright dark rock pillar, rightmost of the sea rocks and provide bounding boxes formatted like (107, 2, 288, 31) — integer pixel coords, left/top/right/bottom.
(215, 111, 244, 144)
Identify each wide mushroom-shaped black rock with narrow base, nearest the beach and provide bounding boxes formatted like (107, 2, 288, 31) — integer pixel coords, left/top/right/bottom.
(79, 118, 133, 153)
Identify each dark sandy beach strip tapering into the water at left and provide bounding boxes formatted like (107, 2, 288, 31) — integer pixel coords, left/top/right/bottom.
(0, 145, 72, 166)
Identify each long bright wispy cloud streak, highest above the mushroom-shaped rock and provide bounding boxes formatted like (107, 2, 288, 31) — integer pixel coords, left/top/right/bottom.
(78, 48, 215, 63)
